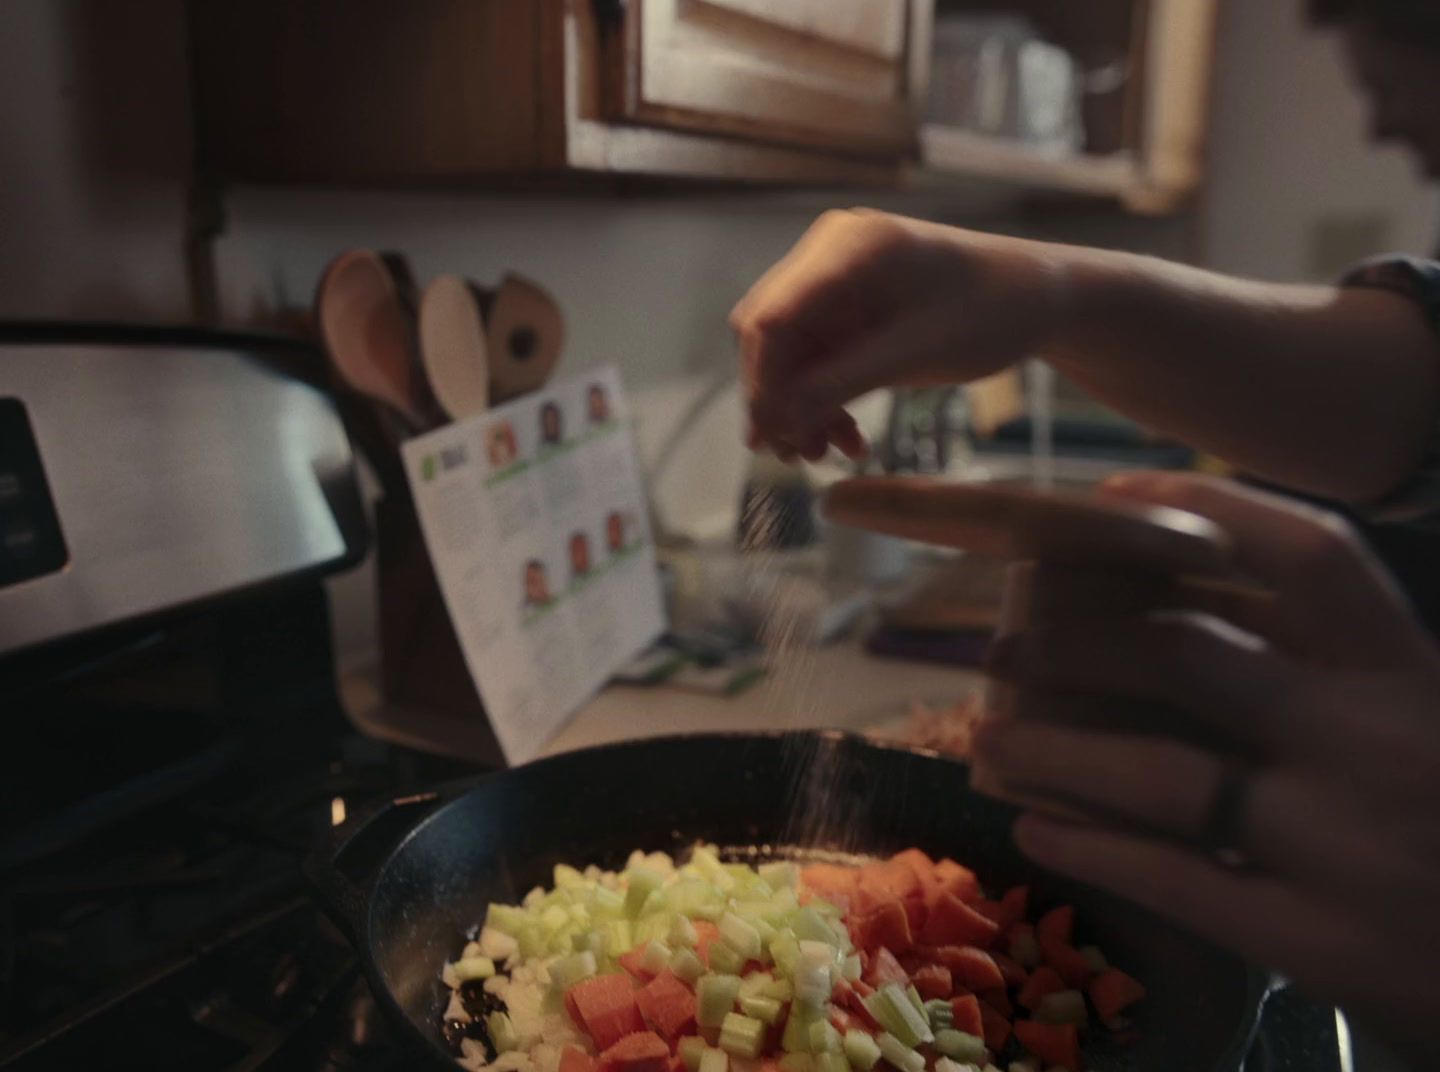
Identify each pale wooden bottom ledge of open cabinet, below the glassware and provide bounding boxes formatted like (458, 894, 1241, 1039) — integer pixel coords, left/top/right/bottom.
(916, 124, 1143, 200)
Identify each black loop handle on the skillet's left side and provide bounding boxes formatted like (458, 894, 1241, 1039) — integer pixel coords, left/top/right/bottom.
(302, 782, 474, 941)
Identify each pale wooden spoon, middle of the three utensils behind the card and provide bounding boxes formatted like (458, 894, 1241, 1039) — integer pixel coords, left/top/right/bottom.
(419, 275, 490, 421)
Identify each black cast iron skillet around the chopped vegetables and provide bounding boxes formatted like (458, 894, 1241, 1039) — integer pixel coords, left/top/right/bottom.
(307, 733, 1266, 1072)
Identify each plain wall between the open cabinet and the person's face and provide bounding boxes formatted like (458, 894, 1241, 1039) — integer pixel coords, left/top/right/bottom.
(1201, 0, 1440, 280)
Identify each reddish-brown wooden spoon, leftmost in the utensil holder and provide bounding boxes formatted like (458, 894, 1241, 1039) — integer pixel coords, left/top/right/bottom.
(315, 249, 433, 435)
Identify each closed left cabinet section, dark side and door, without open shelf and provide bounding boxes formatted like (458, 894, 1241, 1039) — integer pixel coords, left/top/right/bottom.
(189, 0, 927, 186)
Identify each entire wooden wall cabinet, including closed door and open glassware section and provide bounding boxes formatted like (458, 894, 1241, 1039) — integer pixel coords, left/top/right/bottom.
(187, 0, 1218, 210)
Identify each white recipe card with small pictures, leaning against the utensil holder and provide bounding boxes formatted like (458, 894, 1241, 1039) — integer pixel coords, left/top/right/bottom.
(403, 367, 665, 765)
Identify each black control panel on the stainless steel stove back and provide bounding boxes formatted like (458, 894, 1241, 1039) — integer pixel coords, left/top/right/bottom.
(0, 398, 69, 588)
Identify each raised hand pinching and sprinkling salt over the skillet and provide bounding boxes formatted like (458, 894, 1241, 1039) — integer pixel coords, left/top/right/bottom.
(730, 210, 1067, 460)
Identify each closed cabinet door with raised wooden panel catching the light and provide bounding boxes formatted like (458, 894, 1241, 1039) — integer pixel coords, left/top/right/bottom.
(606, 0, 930, 156)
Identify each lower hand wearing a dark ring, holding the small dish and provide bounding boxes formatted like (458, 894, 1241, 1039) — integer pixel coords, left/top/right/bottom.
(976, 474, 1440, 1060)
